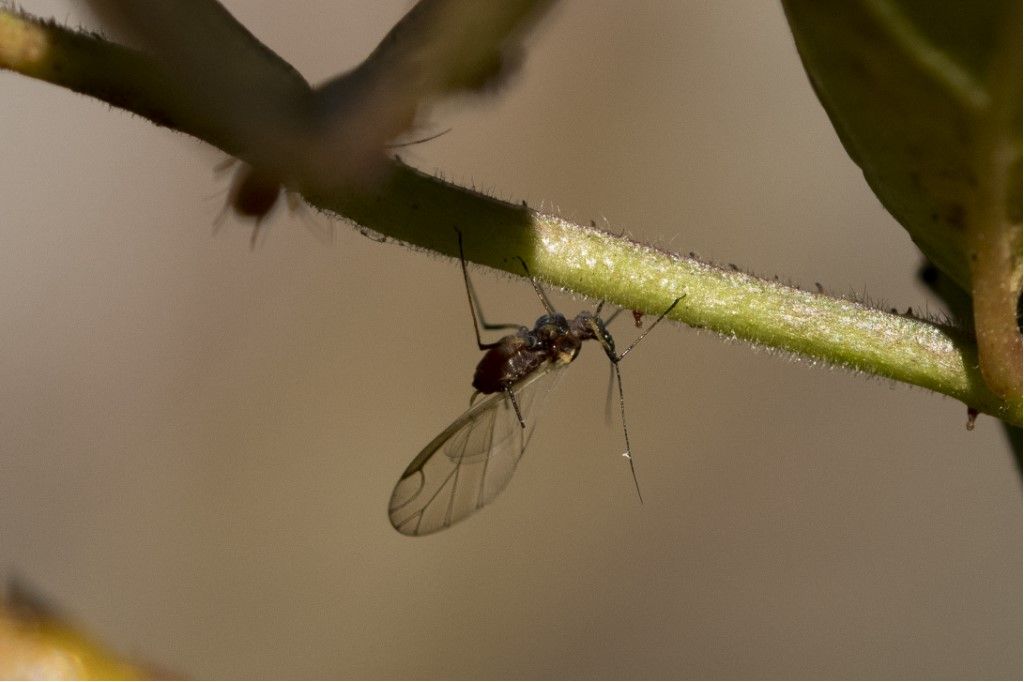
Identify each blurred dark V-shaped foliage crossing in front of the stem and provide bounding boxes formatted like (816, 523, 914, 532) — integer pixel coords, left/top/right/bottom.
(87, 0, 554, 231)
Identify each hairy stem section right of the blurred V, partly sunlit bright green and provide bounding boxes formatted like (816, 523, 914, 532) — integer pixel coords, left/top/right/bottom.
(314, 164, 1021, 424)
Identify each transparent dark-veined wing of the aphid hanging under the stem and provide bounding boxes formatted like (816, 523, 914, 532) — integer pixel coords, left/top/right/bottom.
(388, 364, 564, 536)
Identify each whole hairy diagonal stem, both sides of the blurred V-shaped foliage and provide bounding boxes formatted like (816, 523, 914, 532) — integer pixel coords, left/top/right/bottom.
(0, 10, 1021, 425)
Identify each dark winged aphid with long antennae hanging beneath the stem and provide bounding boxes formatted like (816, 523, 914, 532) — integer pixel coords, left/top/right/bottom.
(388, 233, 682, 536)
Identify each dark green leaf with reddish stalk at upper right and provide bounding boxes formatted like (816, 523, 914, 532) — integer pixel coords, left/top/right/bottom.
(782, 0, 1021, 396)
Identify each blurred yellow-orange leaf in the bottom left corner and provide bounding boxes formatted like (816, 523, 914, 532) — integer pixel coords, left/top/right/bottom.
(0, 587, 164, 680)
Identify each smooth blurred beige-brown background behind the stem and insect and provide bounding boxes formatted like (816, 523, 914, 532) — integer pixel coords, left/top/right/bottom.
(0, 0, 1021, 678)
